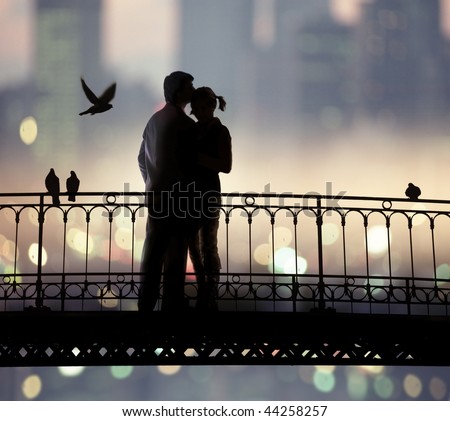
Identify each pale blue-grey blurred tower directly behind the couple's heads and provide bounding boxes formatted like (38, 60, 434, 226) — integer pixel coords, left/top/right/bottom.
(179, 0, 253, 125)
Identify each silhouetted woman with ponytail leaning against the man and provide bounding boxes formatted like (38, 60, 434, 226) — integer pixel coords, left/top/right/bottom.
(189, 87, 232, 310)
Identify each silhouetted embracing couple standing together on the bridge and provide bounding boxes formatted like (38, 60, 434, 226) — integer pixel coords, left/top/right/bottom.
(138, 71, 232, 312)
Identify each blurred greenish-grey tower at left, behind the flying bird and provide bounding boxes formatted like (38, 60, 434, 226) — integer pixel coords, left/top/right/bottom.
(33, 0, 106, 165)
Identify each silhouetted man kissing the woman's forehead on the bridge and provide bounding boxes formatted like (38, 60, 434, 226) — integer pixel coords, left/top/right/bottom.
(138, 71, 195, 312)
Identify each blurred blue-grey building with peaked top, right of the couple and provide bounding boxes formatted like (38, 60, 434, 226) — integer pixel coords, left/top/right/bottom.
(292, 9, 356, 131)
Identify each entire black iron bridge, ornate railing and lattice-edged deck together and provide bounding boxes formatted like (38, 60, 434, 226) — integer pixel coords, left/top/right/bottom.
(0, 193, 450, 366)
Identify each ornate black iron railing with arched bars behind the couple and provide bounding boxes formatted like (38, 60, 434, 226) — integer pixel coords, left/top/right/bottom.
(0, 192, 450, 315)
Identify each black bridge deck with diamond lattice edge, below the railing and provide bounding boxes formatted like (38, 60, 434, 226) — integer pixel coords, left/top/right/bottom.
(0, 311, 450, 366)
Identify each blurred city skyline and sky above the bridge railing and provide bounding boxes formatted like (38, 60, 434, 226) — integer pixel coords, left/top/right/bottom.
(0, 0, 450, 202)
